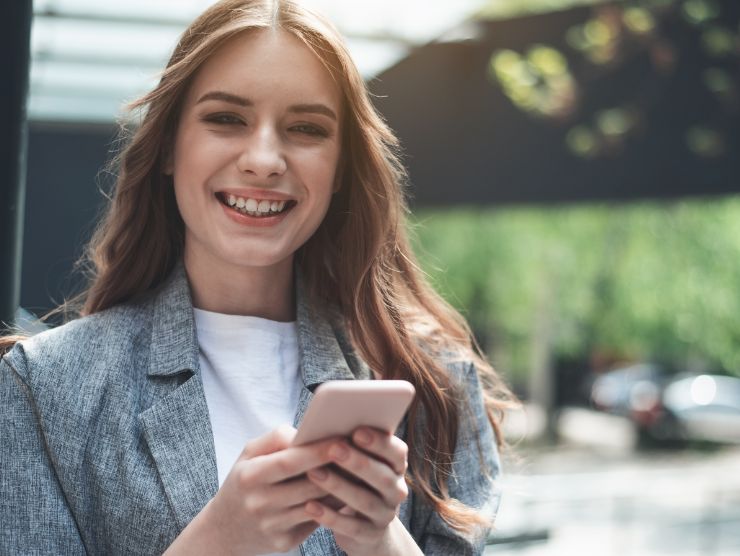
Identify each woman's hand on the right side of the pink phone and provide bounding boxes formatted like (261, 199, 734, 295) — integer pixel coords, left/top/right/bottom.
(305, 427, 421, 556)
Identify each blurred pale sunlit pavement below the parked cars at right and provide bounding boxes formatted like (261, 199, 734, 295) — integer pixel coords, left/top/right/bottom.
(485, 406, 740, 556)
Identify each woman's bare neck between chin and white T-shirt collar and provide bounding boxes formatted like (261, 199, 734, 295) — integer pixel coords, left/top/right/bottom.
(184, 251, 295, 322)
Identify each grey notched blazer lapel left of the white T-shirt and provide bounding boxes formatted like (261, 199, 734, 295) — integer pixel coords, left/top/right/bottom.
(139, 265, 218, 529)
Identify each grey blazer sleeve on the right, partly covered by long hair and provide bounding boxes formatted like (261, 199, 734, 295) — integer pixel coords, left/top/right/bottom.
(412, 363, 500, 556)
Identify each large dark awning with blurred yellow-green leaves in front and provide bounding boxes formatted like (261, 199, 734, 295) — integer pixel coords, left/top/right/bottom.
(371, 0, 740, 205)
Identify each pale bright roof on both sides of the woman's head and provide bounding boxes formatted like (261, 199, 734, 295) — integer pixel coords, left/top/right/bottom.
(29, 0, 490, 122)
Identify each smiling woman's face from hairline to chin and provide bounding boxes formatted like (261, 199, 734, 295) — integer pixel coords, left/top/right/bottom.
(168, 30, 341, 282)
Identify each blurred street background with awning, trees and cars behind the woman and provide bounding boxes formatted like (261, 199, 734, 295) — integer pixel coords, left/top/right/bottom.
(5, 0, 740, 556)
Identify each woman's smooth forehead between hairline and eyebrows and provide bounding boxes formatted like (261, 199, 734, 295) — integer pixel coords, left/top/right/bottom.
(188, 29, 340, 109)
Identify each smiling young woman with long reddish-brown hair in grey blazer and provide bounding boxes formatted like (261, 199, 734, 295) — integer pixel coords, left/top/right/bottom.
(0, 0, 507, 555)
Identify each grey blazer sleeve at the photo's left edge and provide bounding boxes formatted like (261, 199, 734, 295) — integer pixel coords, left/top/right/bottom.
(0, 345, 86, 554)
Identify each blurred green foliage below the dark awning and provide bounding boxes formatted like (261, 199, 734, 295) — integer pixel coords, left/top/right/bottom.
(415, 198, 740, 379)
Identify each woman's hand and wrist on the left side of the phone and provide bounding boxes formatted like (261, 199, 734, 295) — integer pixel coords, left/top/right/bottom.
(165, 426, 332, 556)
